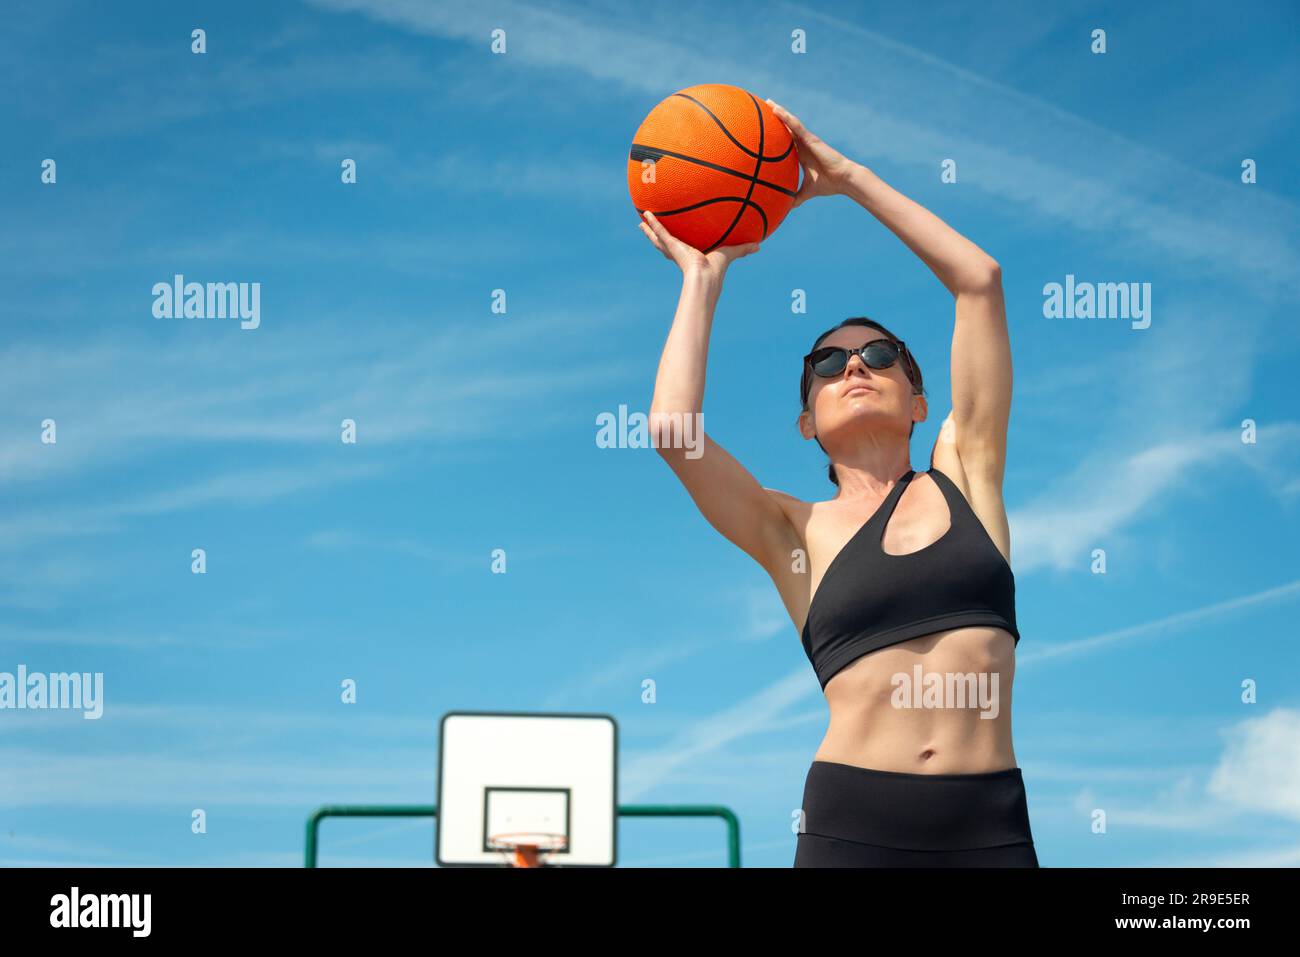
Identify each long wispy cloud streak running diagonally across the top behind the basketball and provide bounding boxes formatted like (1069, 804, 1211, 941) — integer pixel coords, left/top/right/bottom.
(306, 0, 1300, 300)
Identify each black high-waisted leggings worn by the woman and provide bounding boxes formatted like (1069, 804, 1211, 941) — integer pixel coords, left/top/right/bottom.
(794, 761, 1039, 867)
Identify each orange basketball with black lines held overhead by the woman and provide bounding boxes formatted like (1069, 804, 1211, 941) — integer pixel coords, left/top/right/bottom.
(628, 83, 800, 252)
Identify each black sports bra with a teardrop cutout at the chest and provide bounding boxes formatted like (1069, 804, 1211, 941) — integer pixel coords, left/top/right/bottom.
(803, 465, 1021, 689)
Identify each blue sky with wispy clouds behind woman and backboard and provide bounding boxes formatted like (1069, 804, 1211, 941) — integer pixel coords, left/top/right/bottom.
(0, 0, 1300, 867)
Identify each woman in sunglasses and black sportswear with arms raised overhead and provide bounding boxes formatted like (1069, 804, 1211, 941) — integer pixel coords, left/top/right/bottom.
(641, 100, 1039, 867)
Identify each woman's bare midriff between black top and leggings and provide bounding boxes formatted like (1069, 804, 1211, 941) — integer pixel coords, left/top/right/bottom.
(815, 627, 1017, 774)
